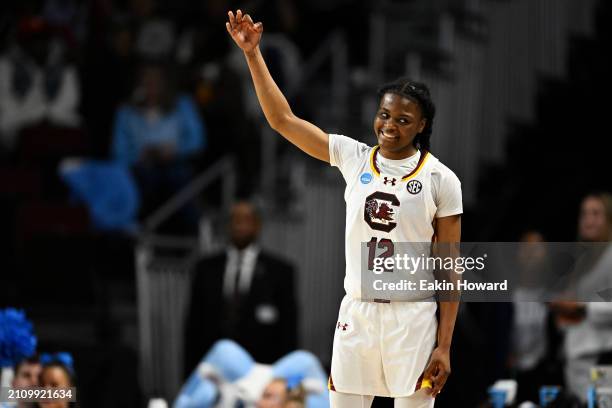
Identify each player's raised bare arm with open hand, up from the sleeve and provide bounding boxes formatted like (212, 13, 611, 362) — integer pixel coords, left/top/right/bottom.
(225, 10, 329, 163)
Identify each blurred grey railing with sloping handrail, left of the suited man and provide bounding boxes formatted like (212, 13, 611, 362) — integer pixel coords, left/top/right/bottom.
(135, 157, 236, 401)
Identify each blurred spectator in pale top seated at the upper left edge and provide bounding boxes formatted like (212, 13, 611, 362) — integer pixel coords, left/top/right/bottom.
(0, 17, 80, 155)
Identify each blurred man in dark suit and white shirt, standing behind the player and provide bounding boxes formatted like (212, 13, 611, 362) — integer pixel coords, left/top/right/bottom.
(185, 202, 297, 373)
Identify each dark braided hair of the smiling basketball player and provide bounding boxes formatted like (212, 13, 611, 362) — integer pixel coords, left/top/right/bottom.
(378, 78, 436, 151)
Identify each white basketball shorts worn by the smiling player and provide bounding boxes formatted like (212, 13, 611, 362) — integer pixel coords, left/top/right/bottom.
(329, 296, 438, 398)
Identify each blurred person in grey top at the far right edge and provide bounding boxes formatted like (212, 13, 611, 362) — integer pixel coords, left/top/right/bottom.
(550, 193, 612, 402)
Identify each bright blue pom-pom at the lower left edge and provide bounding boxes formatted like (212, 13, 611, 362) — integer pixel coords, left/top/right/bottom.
(0, 308, 36, 367)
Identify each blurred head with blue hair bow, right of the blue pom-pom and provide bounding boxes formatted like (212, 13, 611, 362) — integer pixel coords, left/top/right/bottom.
(38, 352, 75, 408)
